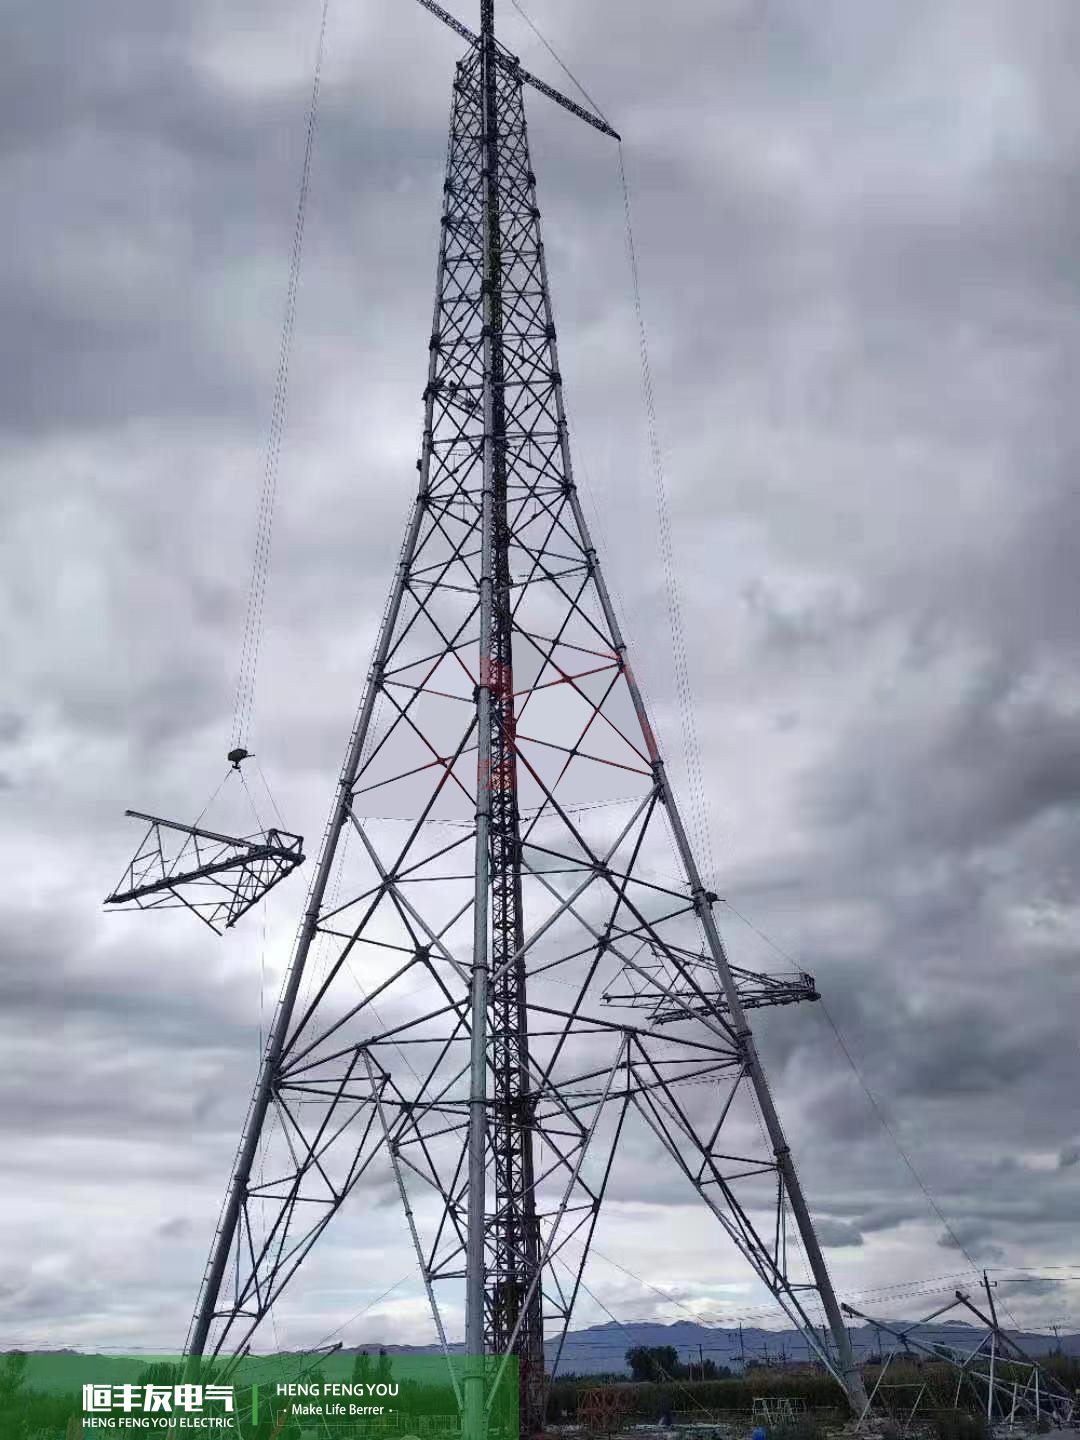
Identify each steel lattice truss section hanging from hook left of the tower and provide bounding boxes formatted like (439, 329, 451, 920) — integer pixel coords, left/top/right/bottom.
(105, 811, 304, 935)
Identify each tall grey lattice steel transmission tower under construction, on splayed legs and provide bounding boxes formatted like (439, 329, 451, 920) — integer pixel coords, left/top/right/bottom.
(187, 0, 864, 1440)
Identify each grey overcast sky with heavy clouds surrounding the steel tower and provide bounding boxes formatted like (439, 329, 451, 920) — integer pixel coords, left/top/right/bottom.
(0, 0, 1080, 1349)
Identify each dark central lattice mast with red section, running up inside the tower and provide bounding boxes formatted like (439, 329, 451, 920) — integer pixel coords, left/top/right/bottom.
(465, 0, 544, 1434)
